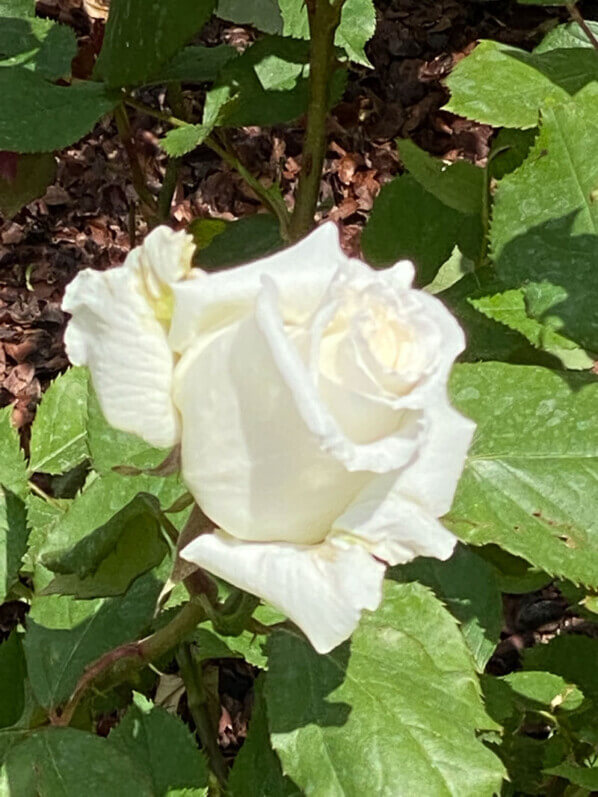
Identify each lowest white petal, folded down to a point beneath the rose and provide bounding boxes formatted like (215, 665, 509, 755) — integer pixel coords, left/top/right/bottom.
(181, 531, 386, 653)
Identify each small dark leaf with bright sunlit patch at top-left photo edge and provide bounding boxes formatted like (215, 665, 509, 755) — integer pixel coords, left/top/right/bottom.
(0, 18, 77, 80)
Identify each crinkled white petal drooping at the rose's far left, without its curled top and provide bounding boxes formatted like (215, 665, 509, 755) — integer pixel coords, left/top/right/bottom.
(62, 268, 179, 447)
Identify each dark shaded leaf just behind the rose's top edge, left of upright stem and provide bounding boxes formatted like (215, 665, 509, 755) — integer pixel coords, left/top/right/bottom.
(198, 213, 284, 271)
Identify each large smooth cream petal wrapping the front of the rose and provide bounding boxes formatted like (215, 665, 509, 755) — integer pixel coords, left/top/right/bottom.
(174, 306, 370, 543)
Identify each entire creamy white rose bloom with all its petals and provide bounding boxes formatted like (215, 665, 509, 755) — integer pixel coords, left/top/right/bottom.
(63, 223, 474, 653)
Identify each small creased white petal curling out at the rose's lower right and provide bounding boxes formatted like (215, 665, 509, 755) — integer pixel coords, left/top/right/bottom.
(332, 476, 457, 565)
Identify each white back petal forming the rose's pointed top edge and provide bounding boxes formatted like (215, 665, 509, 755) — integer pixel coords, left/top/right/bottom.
(170, 222, 356, 352)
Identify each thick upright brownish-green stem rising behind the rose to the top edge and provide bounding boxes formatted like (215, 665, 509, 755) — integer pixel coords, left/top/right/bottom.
(290, 0, 343, 241)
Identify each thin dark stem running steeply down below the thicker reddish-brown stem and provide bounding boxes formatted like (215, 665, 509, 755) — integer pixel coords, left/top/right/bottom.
(177, 642, 228, 786)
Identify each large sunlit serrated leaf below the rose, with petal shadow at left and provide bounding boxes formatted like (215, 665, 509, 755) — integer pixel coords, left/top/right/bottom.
(266, 583, 503, 797)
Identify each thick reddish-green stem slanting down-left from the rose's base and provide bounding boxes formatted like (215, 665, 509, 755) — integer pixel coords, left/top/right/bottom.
(51, 599, 206, 726)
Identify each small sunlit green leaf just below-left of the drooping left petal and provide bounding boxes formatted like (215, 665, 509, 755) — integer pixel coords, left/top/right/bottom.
(29, 368, 89, 473)
